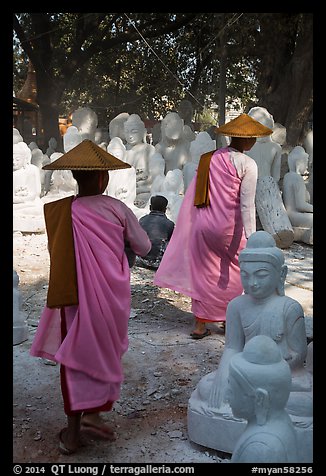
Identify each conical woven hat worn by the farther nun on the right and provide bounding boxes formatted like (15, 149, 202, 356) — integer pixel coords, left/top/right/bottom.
(216, 114, 273, 138)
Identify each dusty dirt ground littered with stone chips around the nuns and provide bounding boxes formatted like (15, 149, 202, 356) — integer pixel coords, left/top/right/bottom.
(13, 233, 312, 464)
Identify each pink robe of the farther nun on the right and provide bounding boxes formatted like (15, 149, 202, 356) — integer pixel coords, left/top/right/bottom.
(154, 148, 246, 322)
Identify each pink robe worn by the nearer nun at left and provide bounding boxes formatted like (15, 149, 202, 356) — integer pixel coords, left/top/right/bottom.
(30, 195, 151, 410)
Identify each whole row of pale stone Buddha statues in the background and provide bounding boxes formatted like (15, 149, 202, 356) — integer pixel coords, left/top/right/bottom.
(14, 101, 313, 248)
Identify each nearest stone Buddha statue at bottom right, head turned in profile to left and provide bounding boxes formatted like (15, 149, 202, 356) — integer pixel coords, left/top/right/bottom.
(227, 335, 299, 463)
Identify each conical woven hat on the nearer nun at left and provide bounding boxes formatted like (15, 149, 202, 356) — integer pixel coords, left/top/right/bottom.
(42, 139, 131, 170)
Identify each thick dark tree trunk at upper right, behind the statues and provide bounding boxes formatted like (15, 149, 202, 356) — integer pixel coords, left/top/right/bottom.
(257, 13, 313, 147)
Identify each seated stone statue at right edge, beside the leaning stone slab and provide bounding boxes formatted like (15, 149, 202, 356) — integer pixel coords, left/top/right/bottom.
(283, 145, 313, 245)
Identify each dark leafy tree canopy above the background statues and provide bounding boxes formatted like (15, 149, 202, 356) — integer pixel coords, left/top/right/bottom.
(13, 13, 313, 145)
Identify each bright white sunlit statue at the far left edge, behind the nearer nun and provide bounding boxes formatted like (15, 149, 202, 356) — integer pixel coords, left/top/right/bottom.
(13, 142, 45, 233)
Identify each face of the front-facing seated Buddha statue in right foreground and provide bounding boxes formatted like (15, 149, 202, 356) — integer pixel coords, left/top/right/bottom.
(240, 261, 281, 299)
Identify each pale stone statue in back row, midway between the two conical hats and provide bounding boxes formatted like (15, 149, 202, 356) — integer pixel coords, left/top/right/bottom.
(155, 112, 191, 173)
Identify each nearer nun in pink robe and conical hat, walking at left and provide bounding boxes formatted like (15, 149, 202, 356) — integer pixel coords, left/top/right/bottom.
(30, 139, 152, 455)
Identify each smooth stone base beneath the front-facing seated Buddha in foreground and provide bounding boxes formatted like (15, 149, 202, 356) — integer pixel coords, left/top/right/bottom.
(187, 404, 313, 463)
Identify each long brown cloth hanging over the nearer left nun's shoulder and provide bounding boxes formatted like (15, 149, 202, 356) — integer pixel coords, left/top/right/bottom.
(44, 196, 78, 308)
